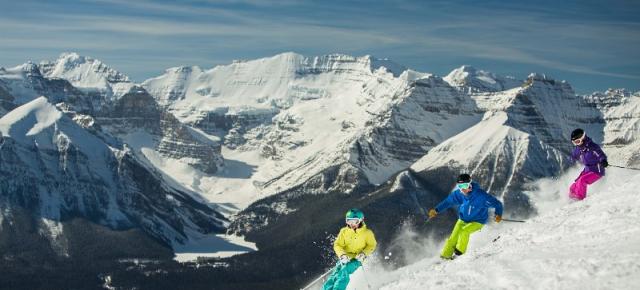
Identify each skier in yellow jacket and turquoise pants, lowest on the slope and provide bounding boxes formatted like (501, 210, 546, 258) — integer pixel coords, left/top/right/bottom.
(322, 208, 377, 290)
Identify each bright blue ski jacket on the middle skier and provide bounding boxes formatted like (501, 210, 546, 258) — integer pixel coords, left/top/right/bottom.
(436, 182, 502, 224)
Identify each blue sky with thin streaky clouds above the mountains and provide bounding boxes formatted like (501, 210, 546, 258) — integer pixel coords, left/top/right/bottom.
(0, 0, 640, 93)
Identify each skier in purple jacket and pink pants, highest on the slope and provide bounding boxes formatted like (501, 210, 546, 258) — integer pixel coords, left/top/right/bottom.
(569, 128, 609, 200)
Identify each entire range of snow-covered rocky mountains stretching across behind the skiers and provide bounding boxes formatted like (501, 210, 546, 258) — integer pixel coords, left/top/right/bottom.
(0, 53, 640, 285)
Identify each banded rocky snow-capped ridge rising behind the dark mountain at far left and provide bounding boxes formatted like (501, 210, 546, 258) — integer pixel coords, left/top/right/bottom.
(0, 53, 223, 190)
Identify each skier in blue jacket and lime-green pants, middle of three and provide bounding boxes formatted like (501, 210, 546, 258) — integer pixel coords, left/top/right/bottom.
(429, 174, 502, 260)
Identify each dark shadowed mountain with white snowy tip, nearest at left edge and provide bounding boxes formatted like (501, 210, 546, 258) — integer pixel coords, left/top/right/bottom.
(0, 97, 226, 245)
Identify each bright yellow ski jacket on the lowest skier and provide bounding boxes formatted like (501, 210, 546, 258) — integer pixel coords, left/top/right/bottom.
(333, 223, 378, 259)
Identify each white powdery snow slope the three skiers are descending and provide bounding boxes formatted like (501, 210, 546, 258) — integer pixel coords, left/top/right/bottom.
(314, 168, 640, 290)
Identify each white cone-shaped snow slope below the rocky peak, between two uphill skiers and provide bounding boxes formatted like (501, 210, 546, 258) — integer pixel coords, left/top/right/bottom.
(411, 112, 569, 213)
